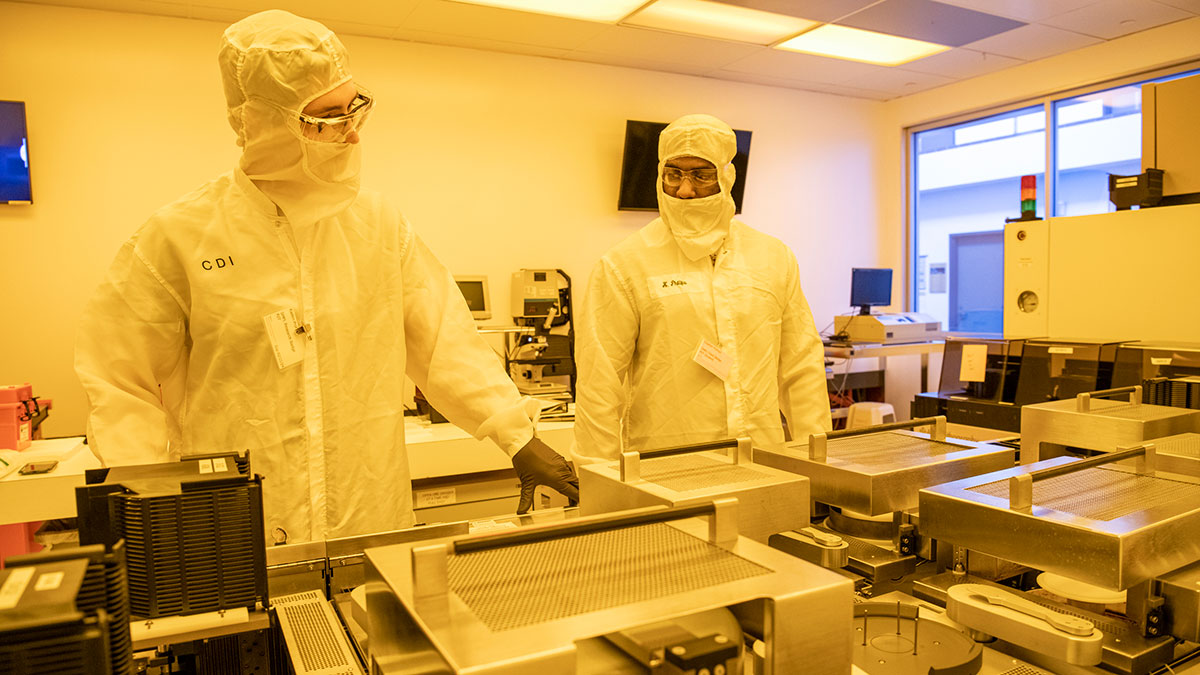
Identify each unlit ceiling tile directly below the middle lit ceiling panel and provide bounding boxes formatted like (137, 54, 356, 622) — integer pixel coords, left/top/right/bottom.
(578, 25, 766, 71)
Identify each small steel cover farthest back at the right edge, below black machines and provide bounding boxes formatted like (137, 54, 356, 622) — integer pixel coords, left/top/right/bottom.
(1021, 386, 1200, 461)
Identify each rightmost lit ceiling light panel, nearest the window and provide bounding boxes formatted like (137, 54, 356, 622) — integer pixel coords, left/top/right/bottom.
(776, 24, 949, 66)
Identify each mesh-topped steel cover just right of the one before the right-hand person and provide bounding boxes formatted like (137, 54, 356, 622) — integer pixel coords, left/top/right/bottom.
(755, 431, 1014, 515)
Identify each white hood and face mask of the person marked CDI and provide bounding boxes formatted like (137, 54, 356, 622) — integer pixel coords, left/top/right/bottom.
(218, 10, 362, 227)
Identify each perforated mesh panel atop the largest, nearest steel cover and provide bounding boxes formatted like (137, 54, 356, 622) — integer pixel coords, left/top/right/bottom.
(449, 522, 772, 631)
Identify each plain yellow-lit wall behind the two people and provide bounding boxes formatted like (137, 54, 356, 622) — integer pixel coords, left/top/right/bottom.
(0, 2, 894, 435)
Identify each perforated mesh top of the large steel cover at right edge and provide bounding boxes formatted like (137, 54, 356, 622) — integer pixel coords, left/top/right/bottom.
(970, 468, 1200, 520)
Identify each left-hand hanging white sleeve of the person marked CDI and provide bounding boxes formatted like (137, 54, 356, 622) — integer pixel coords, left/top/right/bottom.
(74, 240, 187, 466)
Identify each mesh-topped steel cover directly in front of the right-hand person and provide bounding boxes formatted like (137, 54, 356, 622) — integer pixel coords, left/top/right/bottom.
(578, 438, 809, 543)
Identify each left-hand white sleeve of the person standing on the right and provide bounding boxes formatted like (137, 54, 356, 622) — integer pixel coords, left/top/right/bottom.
(572, 258, 638, 464)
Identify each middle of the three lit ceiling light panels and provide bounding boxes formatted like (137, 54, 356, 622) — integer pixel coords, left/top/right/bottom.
(622, 0, 817, 44)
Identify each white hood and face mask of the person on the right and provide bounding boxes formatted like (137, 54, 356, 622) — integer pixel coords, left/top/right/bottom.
(658, 115, 738, 261)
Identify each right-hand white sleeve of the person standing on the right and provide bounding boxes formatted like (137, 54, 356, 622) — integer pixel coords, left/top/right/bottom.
(779, 257, 833, 441)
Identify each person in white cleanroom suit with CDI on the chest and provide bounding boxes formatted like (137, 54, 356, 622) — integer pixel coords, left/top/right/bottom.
(76, 11, 578, 542)
